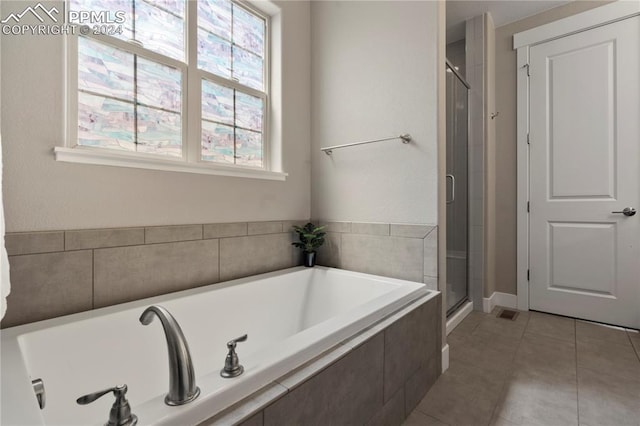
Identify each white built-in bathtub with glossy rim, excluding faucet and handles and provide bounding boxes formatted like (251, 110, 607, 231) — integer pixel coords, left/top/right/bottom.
(1, 267, 437, 425)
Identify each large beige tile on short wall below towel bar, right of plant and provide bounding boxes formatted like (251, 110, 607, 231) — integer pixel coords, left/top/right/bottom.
(340, 234, 424, 282)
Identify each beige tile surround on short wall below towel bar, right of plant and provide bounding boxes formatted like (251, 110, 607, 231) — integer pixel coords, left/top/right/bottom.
(316, 220, 438, 290)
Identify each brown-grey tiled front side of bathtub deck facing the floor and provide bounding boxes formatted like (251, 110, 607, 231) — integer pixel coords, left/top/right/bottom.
(200, 295, 442, 426)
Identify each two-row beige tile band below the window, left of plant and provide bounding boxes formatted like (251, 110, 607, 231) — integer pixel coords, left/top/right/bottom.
(0, 220, 307, 328)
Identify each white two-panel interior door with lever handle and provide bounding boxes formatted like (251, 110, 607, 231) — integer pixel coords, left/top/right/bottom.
(529, 16, 640, 328)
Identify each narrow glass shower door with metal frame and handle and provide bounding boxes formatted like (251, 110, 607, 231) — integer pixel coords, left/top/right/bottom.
(446, 61, 469, 315)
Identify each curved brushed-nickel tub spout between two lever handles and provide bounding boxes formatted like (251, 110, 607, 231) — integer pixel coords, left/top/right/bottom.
(140, 305, 200, 405)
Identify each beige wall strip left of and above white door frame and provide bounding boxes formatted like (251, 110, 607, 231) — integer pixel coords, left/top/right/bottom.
(494, 1, 610, 294)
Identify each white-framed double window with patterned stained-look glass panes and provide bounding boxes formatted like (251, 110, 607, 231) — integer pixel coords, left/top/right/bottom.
(64, 0, 276, 176)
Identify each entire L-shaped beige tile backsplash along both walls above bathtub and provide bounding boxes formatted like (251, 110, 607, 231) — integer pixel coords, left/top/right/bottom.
(0, 220, 437, 328)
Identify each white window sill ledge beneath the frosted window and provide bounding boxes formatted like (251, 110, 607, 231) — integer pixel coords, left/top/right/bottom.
(53, 146, 288, 181)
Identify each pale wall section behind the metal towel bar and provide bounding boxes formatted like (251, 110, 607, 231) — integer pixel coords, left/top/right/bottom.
(311, 1, 438, 224)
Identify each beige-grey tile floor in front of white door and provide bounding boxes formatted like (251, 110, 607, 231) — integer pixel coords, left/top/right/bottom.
(404, 311, 640, 426)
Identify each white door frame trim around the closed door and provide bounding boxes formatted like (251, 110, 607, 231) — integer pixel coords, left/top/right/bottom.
(513, 1, 640, 311)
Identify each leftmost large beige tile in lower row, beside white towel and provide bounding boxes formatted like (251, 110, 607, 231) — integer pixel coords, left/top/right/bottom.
(2, 250, 93, 328)
